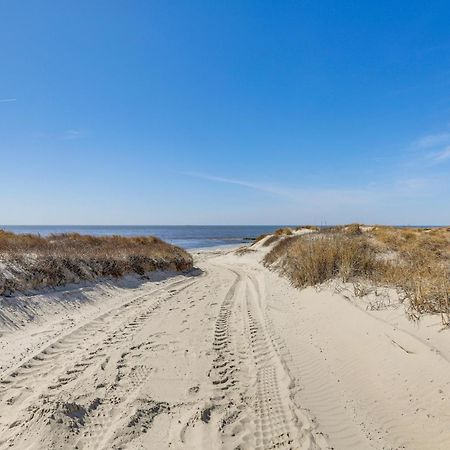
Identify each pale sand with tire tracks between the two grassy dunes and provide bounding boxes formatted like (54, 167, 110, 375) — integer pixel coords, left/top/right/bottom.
(0, 245, 450, 450)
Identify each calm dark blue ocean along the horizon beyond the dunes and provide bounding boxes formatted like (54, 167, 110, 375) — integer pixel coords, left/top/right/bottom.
(0, 225, 286, 249)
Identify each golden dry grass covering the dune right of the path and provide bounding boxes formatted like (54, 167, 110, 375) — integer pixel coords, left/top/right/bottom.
(265, 224, 450, 324)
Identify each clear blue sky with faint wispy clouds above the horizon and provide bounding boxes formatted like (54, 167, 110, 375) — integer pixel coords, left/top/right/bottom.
(0, 0, 450, 224)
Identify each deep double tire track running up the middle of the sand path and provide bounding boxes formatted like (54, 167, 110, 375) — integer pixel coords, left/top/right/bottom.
(182, 267, 328, 450)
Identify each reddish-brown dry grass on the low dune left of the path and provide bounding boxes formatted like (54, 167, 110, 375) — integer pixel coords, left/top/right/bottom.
(0, 230, 193, 295)
